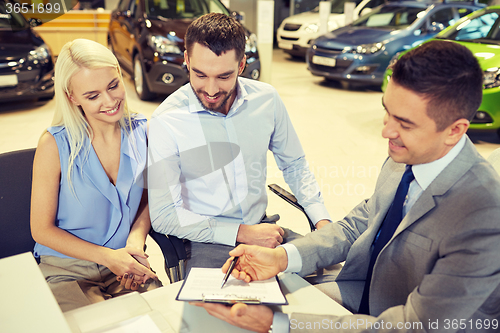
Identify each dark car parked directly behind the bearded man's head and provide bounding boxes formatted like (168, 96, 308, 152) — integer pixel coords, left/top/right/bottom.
(108, 0, 260, 100)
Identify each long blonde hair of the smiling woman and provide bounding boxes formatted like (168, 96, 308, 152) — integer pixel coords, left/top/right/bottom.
(52, 39, 135, 189)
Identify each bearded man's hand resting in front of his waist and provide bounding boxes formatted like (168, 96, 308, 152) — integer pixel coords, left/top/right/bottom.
(236, 223, 285, 249)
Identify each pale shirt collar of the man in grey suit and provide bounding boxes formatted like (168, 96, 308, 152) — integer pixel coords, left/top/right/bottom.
(412, 135, 466, 191)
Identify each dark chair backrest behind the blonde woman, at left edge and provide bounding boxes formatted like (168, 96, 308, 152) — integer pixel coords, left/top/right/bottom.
(0, 148, 35, 258)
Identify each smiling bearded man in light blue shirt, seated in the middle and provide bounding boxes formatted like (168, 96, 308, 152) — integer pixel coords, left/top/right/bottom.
(148, 13, 330, 269)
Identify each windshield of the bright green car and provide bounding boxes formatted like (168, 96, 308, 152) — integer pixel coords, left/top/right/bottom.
(437, 11, 500, 44)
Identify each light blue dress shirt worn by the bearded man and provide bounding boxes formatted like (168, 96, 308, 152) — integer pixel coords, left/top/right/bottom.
(148, 78, 330, 245)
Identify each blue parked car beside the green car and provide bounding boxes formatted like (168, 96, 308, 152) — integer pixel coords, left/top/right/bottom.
(306, 1, 484, 86)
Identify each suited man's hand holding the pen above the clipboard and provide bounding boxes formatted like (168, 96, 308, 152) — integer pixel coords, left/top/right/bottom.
(222, 244, 288, 282)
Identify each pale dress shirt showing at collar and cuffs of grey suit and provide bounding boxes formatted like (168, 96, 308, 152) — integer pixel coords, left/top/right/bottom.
(273, 135, 466, 333)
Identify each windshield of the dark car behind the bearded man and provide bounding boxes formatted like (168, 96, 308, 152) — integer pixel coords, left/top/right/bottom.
(146, 0, 229, 19)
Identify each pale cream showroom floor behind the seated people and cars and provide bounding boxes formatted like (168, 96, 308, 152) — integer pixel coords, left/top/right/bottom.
(0, 50, 500, 283)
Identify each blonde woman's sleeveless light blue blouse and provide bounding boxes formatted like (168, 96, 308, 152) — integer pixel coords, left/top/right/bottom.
(34, 115, 147, 258)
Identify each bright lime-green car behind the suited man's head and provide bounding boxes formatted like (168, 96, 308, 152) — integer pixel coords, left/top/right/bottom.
(382, 6, 500, 135)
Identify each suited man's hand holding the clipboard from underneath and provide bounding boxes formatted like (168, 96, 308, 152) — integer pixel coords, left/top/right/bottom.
(190, 303, 274, 333)
